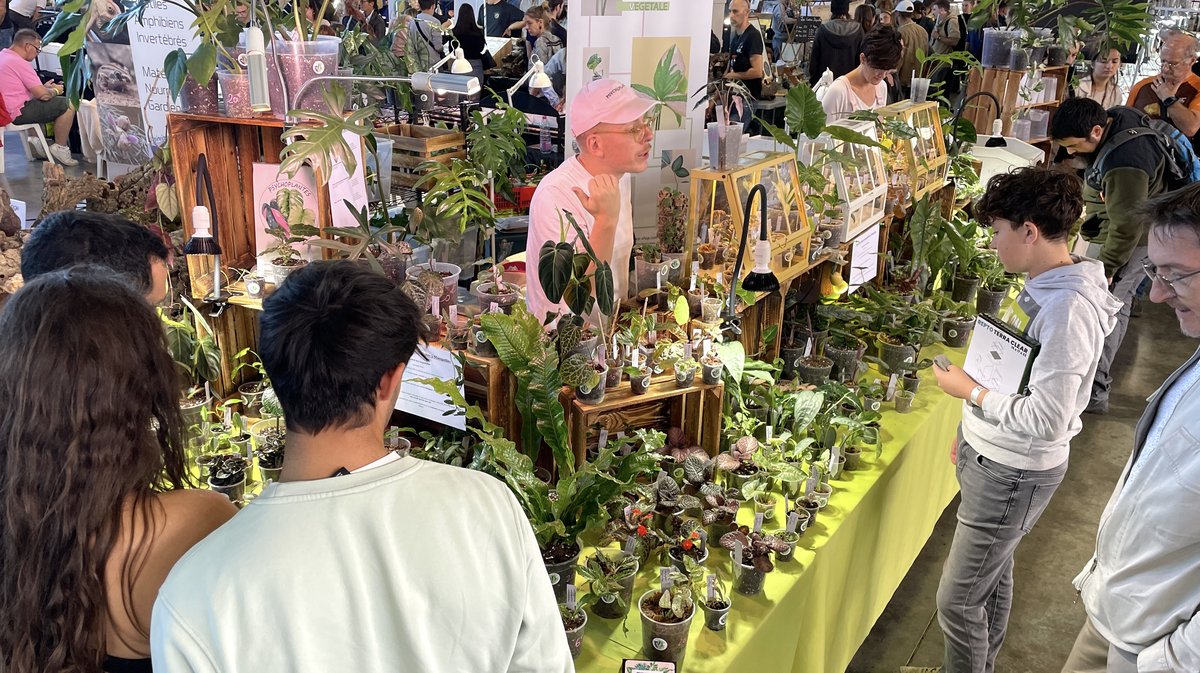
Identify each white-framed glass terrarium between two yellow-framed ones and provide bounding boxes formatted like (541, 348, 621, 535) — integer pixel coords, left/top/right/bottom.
(797, 120, 888, 247)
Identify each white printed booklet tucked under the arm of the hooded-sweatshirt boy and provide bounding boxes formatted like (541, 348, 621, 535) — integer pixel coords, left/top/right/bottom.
(962, 314, 1042, 395)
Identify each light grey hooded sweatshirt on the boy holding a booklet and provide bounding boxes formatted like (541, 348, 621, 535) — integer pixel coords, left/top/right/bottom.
(962, 257, 1121, 470)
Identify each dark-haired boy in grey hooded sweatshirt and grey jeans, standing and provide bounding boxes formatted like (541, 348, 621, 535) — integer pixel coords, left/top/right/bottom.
(934, 168, 1121, 673)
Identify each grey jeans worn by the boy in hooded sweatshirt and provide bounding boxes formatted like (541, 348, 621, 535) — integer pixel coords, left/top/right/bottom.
(937, 439, 1067, 673)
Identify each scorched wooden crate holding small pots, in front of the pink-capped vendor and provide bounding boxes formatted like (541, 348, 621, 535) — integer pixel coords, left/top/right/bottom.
(562, 373, 725, 465)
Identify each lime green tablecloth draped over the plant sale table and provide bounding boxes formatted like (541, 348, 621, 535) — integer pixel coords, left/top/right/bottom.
(575, 348, 962, 673)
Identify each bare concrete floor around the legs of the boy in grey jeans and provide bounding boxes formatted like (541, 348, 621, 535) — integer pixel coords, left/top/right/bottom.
(847, 302, 1198, 673)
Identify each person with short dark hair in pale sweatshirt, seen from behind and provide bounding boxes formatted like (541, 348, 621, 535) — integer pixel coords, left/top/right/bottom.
(150, 262, 574, 673)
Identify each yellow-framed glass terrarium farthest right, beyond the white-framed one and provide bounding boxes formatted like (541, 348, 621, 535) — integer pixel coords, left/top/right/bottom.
(876, 101, 949, 200)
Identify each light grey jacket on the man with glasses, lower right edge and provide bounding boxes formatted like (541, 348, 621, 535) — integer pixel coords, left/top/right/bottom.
(1074, 350, 1200, 673)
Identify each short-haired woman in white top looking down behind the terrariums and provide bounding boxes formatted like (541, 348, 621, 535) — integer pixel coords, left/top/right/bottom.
(821, 25, 901, 121)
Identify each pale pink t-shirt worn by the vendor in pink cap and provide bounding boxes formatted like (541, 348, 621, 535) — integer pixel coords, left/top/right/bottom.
(526, 156, 634, 322)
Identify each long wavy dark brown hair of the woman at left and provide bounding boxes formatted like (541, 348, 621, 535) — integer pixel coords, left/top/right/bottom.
(0, 266, 187, 673)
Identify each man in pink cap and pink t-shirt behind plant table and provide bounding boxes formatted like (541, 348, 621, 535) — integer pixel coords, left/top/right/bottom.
(526, 79, 654, 318)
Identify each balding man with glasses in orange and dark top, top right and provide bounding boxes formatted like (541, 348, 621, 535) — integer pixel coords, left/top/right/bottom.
(1128, 28, 1200, 149)
